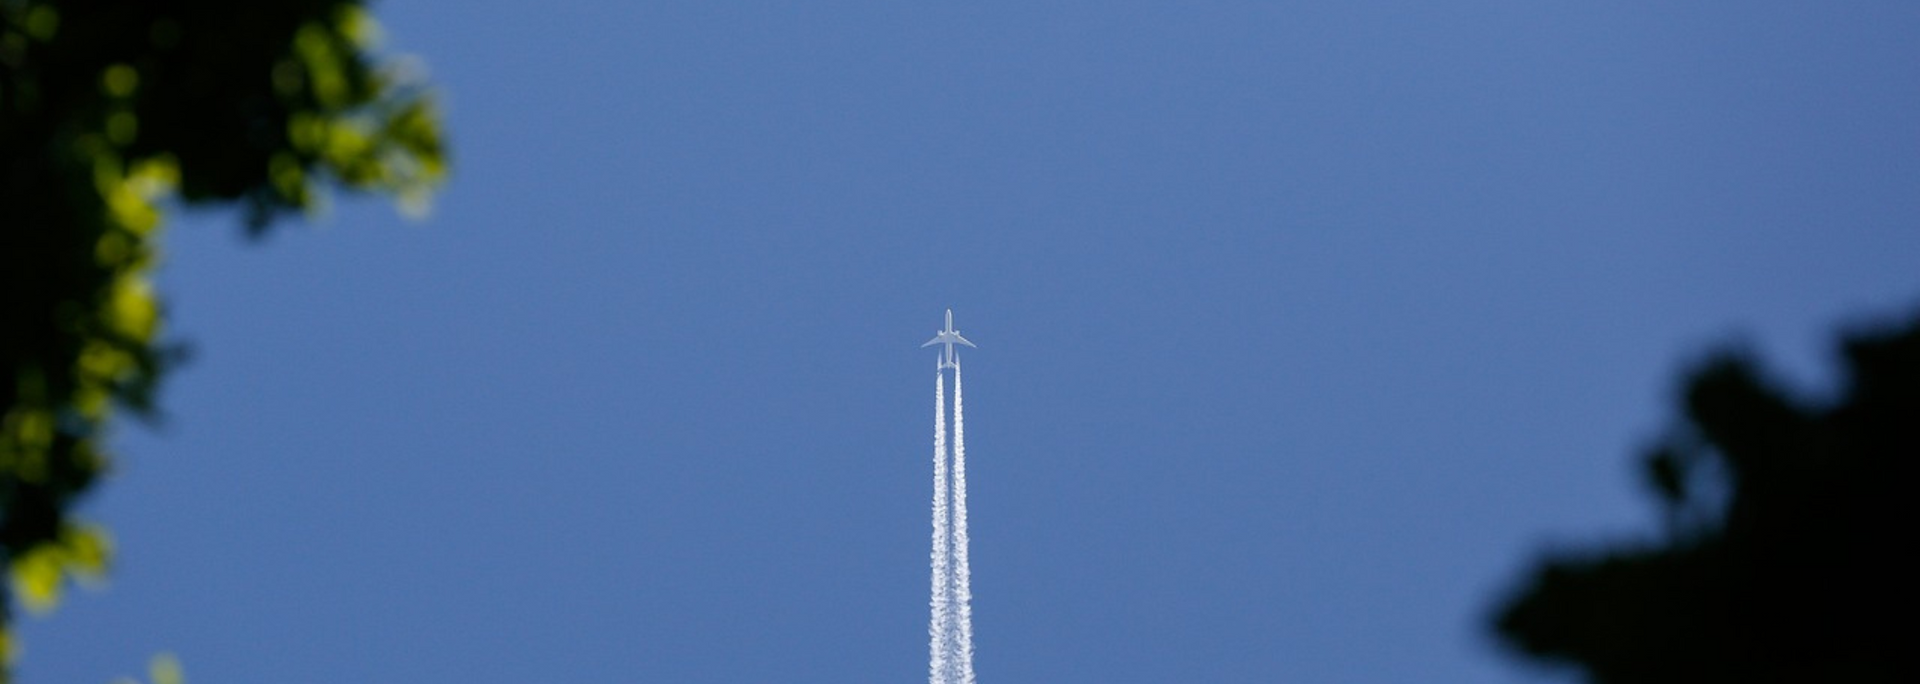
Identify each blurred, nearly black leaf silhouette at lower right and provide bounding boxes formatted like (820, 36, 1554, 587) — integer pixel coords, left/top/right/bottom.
(1496, 307, 1920, 684)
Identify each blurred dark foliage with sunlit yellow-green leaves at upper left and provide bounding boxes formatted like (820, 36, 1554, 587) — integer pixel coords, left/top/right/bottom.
(0, 0, 445, 672)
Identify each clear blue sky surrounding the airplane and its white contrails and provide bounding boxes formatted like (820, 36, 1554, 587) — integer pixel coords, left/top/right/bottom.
(19, 0, 1920, 684)
